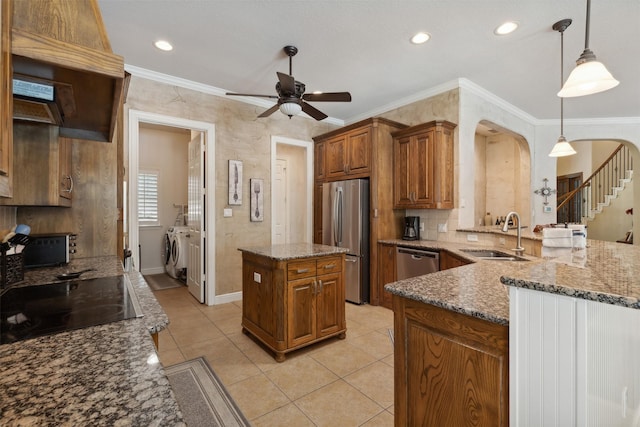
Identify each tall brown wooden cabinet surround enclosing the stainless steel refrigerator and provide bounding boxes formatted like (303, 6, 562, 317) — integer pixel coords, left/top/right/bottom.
(313, 117, 407, 305)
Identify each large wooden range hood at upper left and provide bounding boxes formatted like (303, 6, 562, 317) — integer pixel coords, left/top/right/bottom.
(11, 0, 125, 142)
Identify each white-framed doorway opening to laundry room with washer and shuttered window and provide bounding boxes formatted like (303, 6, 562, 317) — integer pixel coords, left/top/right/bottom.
(125, 110, 215, 305)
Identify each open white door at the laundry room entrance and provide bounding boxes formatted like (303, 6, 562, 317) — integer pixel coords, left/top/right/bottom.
(187, 132, 207, 303)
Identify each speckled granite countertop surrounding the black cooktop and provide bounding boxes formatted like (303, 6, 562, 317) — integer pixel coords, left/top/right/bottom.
(0, 256, 184, 426)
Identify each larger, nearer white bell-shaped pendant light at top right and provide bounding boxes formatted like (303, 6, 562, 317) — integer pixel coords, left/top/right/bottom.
(558, 0, 620, 98)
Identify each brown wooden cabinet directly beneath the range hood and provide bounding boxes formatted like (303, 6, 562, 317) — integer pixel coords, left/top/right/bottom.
(0, 122, 73, 207)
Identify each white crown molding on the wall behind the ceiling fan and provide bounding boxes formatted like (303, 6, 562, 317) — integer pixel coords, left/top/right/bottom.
(124, 64, 345, 126)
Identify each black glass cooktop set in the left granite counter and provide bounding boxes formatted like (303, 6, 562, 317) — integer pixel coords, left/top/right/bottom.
(0, 276, 136, 344)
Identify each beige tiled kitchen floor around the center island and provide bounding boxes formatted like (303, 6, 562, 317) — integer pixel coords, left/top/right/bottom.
(154, 287, 393, 427)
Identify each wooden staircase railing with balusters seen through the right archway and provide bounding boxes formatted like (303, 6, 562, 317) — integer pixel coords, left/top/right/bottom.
(556, 144, 633, 216)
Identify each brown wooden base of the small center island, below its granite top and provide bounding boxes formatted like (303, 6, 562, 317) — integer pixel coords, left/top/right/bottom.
(242, 252, 347, 362)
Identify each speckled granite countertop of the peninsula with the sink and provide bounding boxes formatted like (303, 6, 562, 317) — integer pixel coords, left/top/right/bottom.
(380, 239, 640, 325)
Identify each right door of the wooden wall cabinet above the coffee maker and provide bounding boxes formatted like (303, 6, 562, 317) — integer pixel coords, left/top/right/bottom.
(410, 131, 435, 208)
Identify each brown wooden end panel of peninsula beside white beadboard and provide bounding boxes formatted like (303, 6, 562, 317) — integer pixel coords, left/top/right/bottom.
(393, 295, 509, 427)
